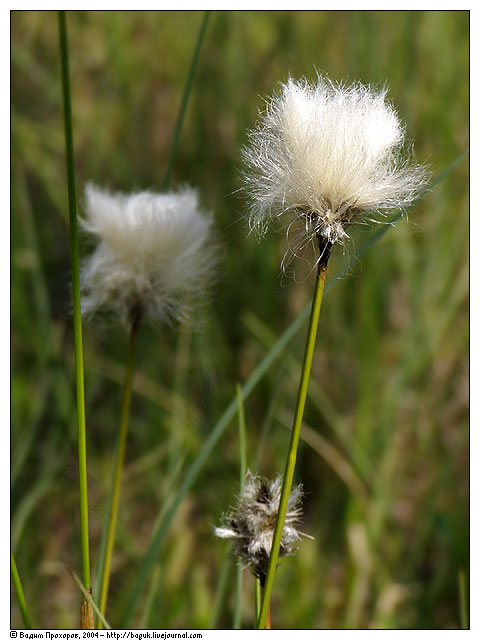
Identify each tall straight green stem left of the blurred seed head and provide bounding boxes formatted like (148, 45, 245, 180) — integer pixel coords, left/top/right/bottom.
(58, 11, 91, 590)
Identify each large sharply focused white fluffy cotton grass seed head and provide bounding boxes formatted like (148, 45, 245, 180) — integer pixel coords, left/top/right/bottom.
(243, 76, 428, 262)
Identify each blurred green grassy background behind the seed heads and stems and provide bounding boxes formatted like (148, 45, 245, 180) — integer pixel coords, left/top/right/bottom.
(11, 11, 469, 629)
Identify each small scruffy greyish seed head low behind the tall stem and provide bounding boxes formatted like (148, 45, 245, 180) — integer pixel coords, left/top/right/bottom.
(215, 471, 305, 580)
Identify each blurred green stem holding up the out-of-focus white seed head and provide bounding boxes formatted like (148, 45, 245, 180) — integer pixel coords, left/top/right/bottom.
(99, 314, 140, 615)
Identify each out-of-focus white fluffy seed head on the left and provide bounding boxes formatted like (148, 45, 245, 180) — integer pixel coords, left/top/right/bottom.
(81, 184, 216, 323)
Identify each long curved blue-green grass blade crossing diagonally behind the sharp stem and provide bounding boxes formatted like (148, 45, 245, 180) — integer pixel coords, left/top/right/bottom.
(122, 153, 465, 628)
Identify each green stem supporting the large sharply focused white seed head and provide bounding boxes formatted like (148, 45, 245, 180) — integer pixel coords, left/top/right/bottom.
(258, 265, 327, 629)
